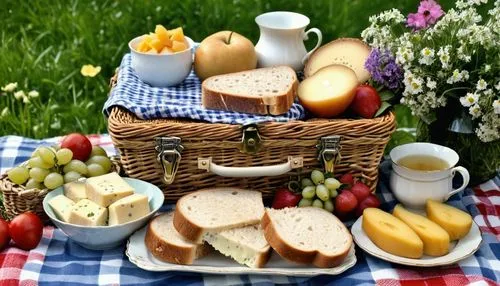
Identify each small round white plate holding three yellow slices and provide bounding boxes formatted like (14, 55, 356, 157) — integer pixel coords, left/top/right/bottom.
(351, 216, 483, 267)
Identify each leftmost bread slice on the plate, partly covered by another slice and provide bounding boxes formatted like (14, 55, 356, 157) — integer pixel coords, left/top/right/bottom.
(144, 211, 210, 264)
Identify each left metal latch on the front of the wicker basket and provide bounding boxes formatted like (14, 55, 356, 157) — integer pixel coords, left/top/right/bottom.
(155, 137, 184, 184)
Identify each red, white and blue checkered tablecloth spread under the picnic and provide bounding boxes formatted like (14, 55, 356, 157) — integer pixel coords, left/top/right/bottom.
(0, 135, 500, 286)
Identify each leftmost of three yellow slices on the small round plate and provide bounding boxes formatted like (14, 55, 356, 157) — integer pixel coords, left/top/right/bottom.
(361, 208, 424, 258)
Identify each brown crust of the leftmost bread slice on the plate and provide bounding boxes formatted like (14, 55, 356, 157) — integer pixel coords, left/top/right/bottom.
(144, 214, 209, 265)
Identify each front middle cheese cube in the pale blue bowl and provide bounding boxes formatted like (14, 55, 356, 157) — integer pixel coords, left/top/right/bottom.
(68, 199, 108, 226)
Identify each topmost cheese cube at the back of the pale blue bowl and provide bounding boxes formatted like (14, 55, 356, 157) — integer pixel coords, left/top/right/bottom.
(86, 172, 134, 207)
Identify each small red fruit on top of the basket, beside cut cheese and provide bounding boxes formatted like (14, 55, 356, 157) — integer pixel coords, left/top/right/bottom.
(351, 84, 382, 118)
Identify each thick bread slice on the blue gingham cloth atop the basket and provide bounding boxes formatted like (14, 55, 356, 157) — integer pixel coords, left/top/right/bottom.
(201, 66, 299, 115)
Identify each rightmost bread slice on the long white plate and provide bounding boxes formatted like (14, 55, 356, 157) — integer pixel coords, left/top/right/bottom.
(262, 207, 352, 268)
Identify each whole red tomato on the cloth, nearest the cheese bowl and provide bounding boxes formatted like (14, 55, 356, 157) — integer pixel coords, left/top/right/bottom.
(9, 212, 43, 250)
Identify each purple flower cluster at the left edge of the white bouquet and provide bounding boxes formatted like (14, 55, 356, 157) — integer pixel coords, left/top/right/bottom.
(365, 48, 403, 90)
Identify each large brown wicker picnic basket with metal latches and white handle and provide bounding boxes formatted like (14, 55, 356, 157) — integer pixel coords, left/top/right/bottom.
(108, 107, 395, 201)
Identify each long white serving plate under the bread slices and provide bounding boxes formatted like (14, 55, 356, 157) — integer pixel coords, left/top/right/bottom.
(125, 226, 356, 277)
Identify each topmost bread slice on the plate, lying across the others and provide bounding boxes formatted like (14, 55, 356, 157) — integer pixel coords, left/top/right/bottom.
(174, 188, 264, 243)
